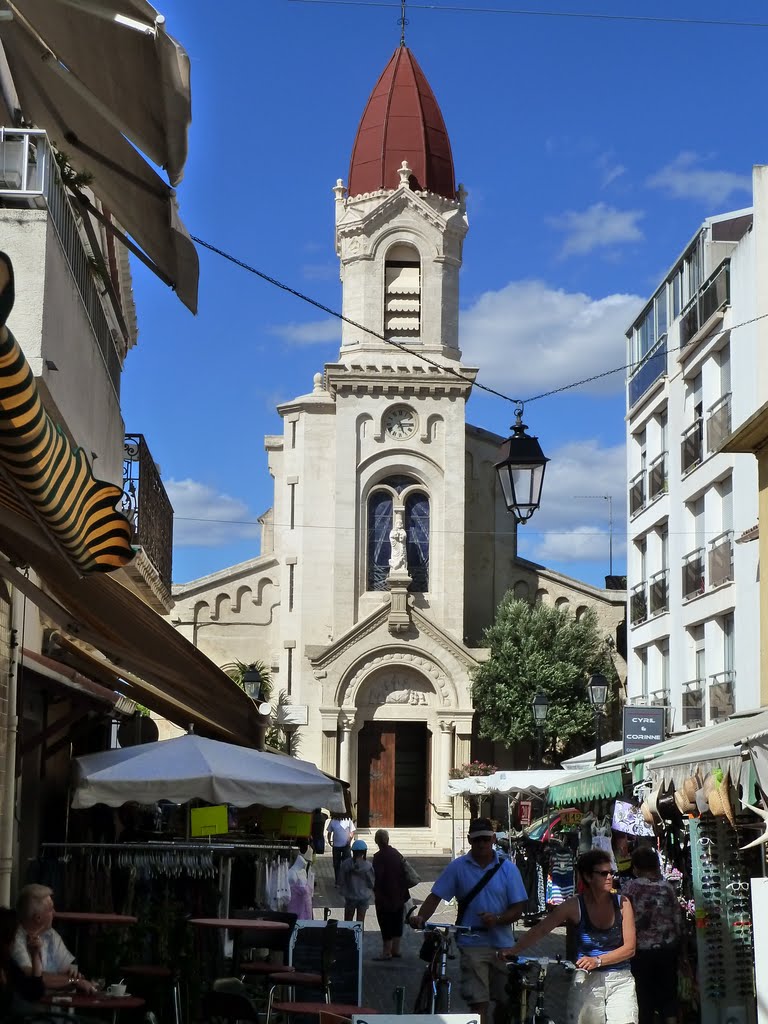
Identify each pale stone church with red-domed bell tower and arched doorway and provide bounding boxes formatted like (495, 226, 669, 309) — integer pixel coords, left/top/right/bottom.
(169, 45, 626, 851)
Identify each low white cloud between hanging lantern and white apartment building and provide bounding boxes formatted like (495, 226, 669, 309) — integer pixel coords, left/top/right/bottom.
(517, 439, 627, 573)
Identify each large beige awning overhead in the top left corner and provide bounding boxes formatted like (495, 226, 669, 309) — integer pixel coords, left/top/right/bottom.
(0, 0, 199, 312)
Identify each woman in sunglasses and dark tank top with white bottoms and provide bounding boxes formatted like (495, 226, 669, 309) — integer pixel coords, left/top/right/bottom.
(499, 850, 638, 1024)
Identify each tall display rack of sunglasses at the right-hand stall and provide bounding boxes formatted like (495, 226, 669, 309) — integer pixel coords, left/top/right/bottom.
(688, 817, 756, 1024)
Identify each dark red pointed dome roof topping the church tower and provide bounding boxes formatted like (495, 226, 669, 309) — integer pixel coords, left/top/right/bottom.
(347, 46, 456, 199)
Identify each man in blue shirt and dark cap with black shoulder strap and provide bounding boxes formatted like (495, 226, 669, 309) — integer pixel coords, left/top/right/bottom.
(409, 818, 528, 1024)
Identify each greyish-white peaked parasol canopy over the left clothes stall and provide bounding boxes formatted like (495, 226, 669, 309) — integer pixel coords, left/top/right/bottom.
(72, 735, 346, 813)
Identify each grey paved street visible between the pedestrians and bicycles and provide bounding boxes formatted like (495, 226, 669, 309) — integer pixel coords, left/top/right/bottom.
(314, 853, 567, 1022)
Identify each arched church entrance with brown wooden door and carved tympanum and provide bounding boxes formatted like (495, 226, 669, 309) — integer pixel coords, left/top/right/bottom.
(348, 663, 441, 828)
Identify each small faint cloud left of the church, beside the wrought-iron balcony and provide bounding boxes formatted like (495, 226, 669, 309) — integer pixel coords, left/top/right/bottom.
(165, 477, 261, 553)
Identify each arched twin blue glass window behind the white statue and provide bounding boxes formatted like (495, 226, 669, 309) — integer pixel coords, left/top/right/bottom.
(367, 476, 429, 594)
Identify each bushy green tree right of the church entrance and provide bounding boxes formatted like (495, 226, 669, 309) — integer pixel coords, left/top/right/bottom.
(472, 593, 617, 754)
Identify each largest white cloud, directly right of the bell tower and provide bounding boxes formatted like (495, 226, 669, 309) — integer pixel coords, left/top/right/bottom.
(461, 281, 643, 398)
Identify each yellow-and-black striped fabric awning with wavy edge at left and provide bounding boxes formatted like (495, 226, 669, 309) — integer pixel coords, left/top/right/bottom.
(0, 331, 135, 572)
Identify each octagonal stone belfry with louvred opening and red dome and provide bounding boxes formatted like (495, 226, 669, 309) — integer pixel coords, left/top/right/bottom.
(334, 45, 468, 364)
